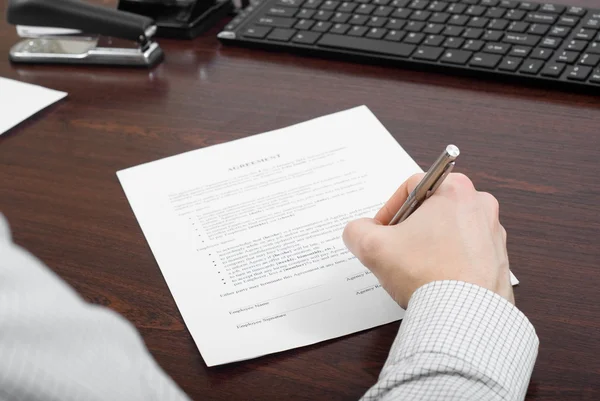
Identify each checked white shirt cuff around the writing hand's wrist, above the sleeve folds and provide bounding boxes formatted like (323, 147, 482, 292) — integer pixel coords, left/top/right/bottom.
(381, 281, 539, 399)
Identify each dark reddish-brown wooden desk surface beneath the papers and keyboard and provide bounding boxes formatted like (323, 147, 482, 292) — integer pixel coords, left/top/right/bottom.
(0, 0, 600, 401)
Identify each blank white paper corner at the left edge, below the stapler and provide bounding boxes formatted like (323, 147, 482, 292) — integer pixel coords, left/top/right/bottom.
(0, 77, 67, 135)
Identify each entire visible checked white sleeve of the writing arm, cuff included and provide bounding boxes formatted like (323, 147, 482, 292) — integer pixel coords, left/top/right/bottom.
(363, 281, 539, 401)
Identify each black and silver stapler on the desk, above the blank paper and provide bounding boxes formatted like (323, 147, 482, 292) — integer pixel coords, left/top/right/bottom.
(7, 0, 163, 67)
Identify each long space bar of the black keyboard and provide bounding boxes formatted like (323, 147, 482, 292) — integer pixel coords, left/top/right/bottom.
(317, 33, 416, 57)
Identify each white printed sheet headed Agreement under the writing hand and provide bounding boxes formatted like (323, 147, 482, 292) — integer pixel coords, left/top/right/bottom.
(117, 106, 516, 366)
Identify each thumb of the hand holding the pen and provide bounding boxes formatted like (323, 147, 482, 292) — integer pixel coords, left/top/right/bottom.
(342, 218, 390, 269)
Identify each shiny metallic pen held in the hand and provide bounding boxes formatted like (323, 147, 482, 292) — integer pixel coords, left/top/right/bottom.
(389, 145, 460, 226)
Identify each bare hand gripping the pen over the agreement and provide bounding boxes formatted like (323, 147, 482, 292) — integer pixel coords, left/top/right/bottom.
(343, 173, 514, 308)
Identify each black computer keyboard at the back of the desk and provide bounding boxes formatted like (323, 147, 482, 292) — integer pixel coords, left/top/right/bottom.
(218, 0, 600, 89)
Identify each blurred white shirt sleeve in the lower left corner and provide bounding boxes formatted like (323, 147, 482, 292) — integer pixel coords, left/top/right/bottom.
(0, 214, 188, 401)
